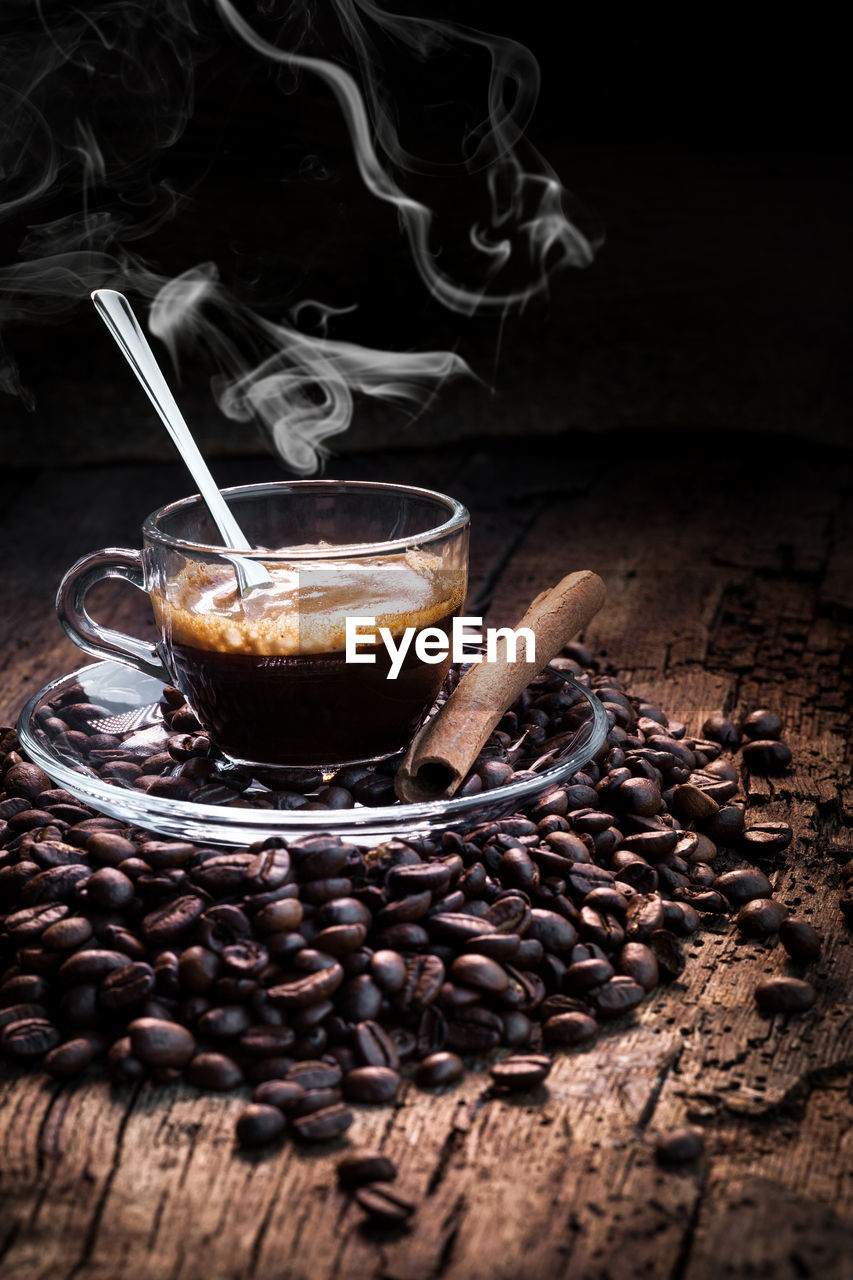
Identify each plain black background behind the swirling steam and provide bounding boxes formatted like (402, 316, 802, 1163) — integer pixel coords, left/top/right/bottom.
(0, 0, 853, 465)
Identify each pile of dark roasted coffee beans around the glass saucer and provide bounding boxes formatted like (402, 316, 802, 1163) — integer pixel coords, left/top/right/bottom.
(0, 646, 820, 1167)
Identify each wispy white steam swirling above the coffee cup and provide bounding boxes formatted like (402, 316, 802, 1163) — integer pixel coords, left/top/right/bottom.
(0, 0, 598, 474)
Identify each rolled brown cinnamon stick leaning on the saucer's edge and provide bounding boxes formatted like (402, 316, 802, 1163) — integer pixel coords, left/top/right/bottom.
(394, 570, 606, 804)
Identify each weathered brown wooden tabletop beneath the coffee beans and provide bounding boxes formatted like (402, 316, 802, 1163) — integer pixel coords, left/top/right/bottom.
(0, 430, 853, 1280)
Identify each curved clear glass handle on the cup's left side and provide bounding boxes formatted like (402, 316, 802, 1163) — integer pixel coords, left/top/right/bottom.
(56, 547, 170, 684)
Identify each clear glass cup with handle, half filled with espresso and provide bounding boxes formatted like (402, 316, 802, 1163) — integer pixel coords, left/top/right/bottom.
(56, 480, 469, 768)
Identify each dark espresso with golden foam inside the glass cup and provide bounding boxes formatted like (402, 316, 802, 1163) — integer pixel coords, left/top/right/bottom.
(151, 554, 465, 765)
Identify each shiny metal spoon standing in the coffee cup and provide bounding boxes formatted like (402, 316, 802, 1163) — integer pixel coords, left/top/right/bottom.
(91, 289, 273, 595)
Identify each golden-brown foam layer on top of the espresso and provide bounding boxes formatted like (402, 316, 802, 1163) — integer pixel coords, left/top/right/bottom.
(151, 550, 465, 655)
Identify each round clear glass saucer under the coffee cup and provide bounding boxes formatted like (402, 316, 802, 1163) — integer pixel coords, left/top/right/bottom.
(18, 662, 607, 846)
